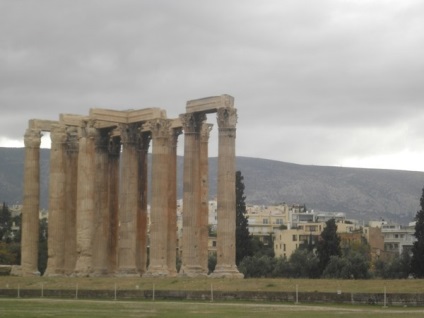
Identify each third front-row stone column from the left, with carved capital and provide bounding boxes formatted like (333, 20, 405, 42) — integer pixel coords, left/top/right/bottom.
(75, 122, 97, 276)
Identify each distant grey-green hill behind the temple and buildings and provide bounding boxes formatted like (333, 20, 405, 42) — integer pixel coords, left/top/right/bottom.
(0, 148, 424, 223)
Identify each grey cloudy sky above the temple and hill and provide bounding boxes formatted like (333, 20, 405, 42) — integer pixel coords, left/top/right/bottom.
(0, 0, 424, 171)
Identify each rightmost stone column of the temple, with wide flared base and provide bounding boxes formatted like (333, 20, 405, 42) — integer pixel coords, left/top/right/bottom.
(211, 107, 243, 278)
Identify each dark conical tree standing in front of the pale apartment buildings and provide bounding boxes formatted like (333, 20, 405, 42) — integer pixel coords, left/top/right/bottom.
(317, 219, 342, 273)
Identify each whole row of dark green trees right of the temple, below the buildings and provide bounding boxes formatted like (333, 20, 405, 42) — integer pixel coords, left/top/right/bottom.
(236, 171, 424, 279)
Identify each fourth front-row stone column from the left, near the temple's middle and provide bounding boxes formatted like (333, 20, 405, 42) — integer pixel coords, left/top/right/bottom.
(117, 124, 140, 276)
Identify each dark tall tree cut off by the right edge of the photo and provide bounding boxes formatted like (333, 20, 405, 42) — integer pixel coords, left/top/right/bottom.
(411, 188, 424, 278)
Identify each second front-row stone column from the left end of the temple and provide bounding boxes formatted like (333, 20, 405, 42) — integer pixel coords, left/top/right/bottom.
(44, 124, 66, 276)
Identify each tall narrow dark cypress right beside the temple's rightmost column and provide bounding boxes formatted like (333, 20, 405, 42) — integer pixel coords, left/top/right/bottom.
(236, 171, 253, 265)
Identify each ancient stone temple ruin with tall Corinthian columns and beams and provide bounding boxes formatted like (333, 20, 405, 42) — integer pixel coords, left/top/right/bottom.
(21, 95, 243, 277)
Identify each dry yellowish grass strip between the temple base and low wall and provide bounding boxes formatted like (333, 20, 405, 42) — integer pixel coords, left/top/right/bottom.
(0, 276, 424, 293)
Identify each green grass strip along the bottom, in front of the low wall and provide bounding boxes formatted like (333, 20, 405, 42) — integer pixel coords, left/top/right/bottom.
(0, 299, 424, 318)
